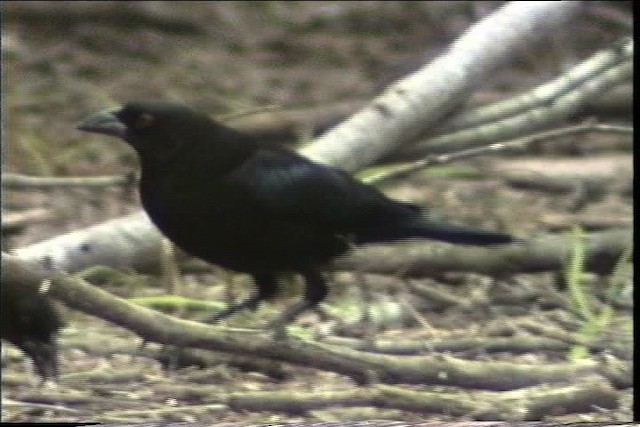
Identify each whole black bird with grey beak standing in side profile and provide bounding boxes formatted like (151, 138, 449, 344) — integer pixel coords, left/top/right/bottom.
(78, 102, 516, 336)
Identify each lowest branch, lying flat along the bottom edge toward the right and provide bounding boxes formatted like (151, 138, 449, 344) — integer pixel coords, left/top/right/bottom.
(225, 381, 618, 421)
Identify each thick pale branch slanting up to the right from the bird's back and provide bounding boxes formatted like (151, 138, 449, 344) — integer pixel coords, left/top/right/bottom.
(303, 1, 580, 171)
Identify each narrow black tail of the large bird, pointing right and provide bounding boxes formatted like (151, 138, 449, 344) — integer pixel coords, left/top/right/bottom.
(356, 218, 522, 246)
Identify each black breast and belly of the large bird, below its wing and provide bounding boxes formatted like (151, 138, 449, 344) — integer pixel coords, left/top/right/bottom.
(141, 185, 346, 273)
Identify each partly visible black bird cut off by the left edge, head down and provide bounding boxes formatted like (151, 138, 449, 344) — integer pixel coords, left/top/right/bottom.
(0, 280, 64, 381)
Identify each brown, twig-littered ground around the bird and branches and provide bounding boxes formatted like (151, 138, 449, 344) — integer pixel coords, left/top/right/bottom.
(2, 1, 633, 424)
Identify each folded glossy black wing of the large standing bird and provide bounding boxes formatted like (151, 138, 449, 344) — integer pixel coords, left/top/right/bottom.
(229, 148, 421, 228)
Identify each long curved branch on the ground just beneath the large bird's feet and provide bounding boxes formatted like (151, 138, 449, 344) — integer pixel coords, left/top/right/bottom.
(2, 254, 598, 390)
